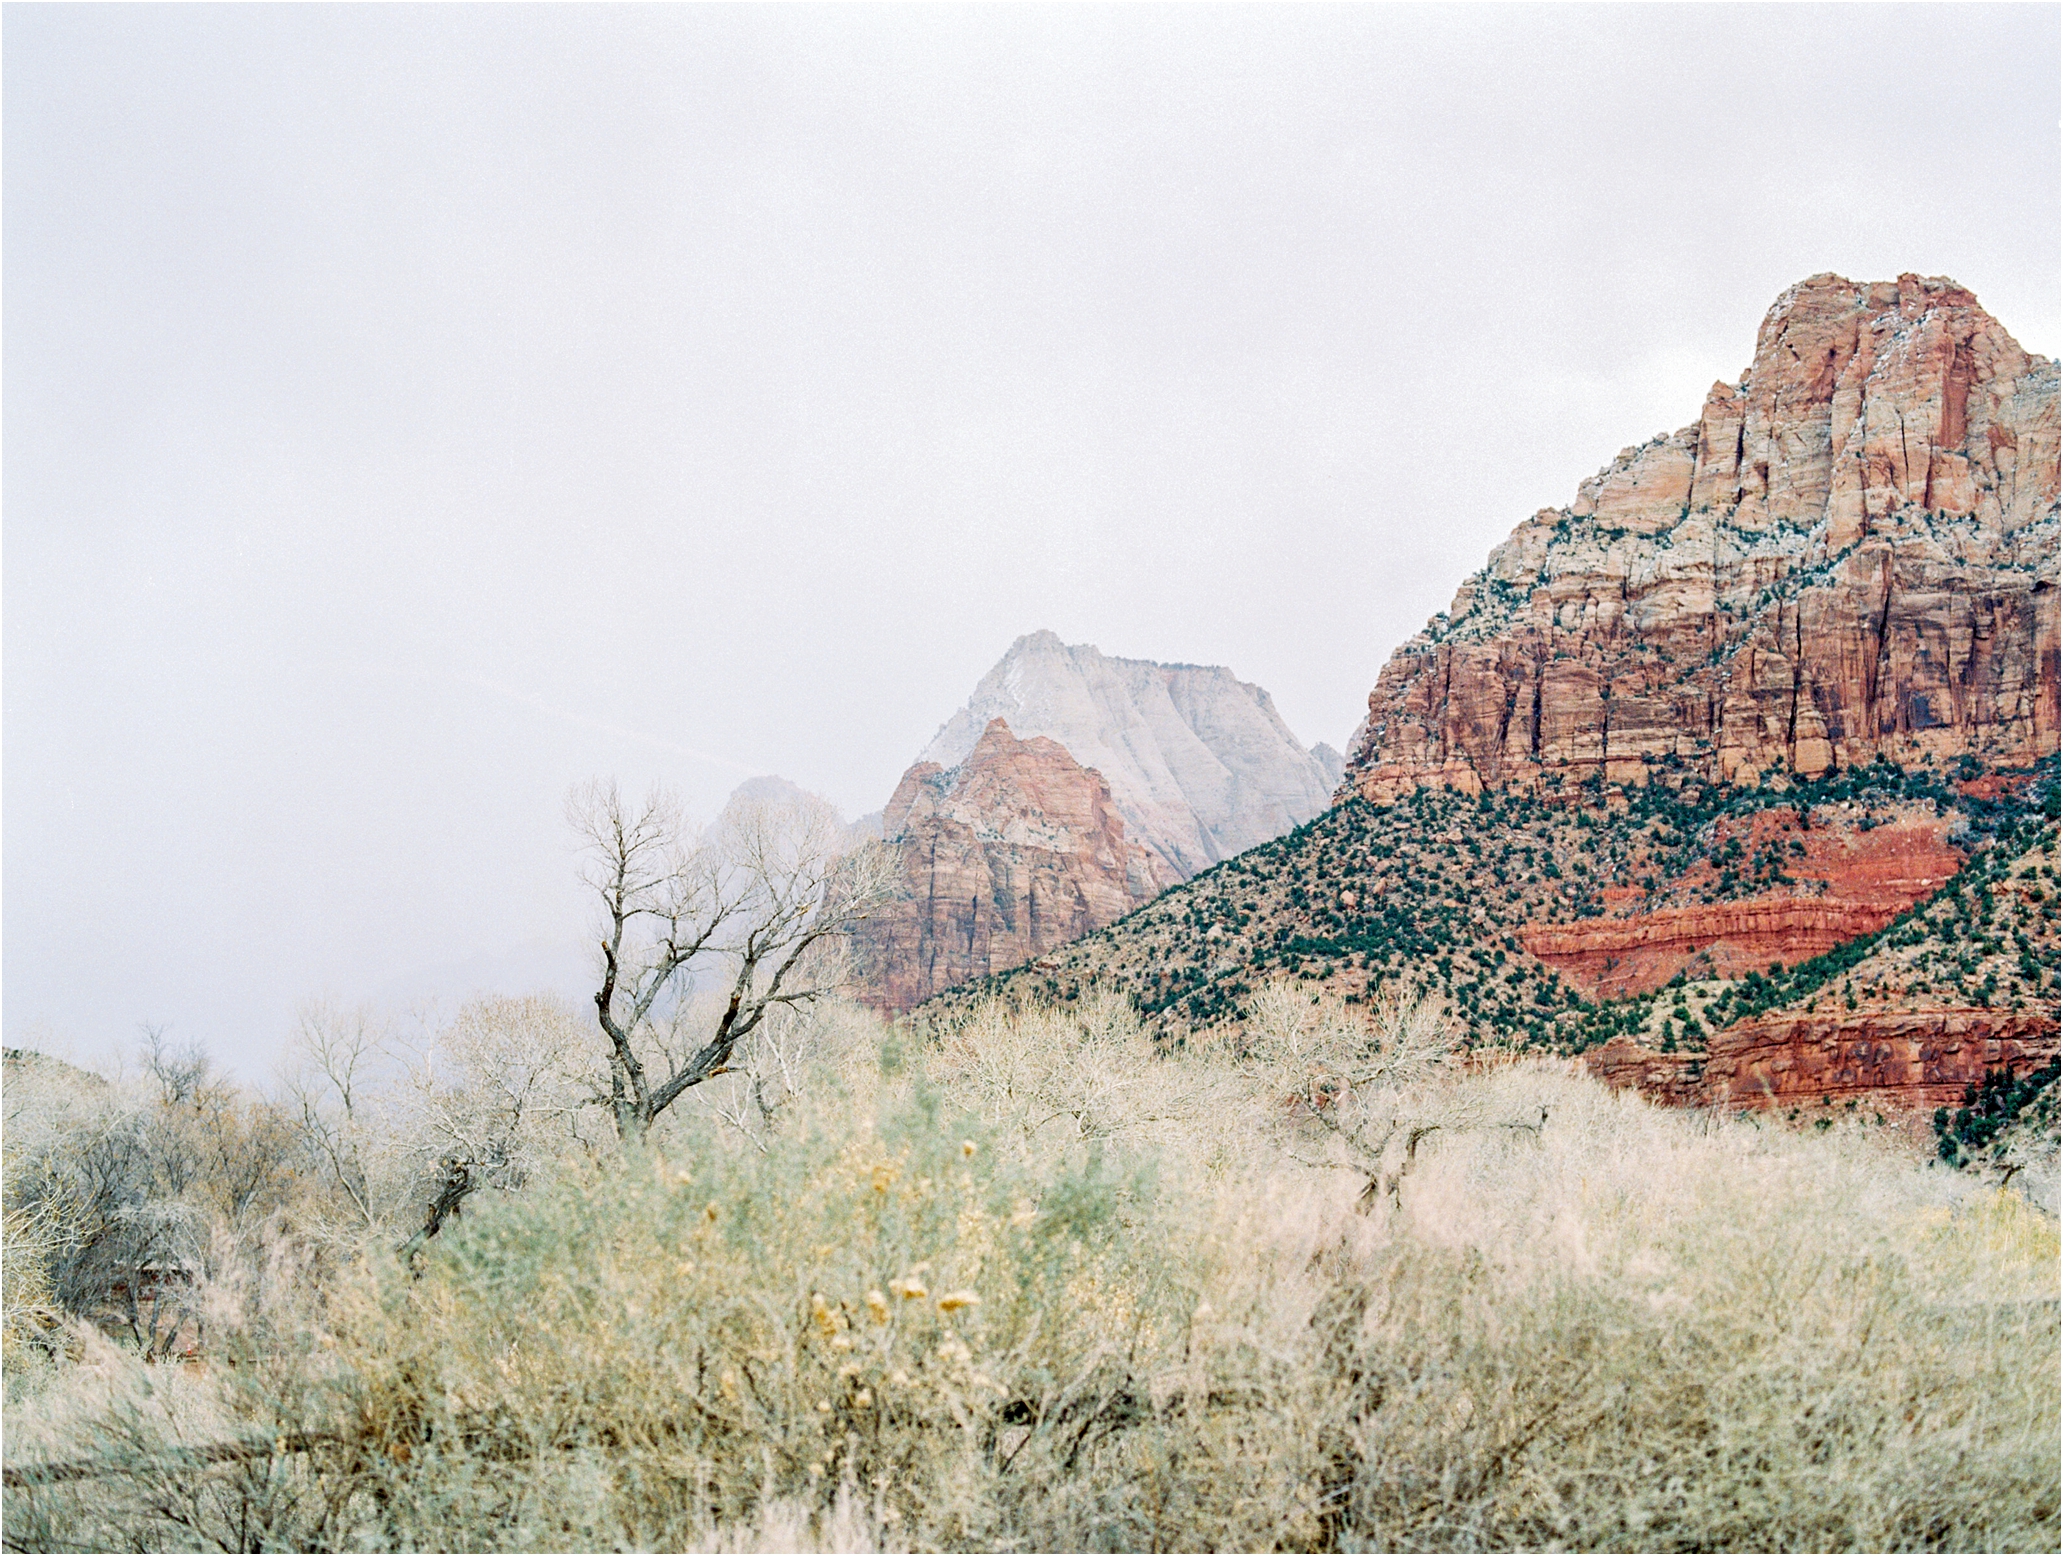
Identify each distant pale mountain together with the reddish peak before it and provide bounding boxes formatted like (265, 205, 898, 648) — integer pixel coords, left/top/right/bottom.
(854, 631, 1341, 1011)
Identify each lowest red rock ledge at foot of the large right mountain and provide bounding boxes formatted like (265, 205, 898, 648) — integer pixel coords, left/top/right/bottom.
(1584, 1009, 2057, 1110)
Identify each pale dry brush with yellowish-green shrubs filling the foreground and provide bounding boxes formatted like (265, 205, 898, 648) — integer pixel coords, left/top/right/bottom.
(6, 991, 2059, 1550)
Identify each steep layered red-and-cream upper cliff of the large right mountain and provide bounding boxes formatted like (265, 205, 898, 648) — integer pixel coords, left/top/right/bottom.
(1345, 274, 2059, 803)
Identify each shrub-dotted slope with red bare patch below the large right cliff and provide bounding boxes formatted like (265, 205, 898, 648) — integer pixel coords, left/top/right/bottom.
(947, 764, 2059, 1085)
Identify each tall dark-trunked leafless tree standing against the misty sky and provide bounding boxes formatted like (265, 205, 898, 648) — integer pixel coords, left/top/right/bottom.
(567, 782, 893, 1141)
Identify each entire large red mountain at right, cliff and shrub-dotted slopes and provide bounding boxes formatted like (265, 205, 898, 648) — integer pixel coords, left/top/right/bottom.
(947, 274, 2063, 1110)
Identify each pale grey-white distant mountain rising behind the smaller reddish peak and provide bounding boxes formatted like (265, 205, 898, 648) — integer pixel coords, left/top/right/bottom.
(924, 631, 1339, 881)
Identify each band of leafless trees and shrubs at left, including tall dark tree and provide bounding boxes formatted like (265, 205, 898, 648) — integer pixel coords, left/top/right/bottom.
(4, 784, 887, 1358)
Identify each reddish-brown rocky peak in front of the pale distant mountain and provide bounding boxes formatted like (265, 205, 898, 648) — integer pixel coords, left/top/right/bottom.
(854, 718, 1172, 1013)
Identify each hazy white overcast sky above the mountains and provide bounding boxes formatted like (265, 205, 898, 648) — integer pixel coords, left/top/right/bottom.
(0, 4, 2063, 1075)
